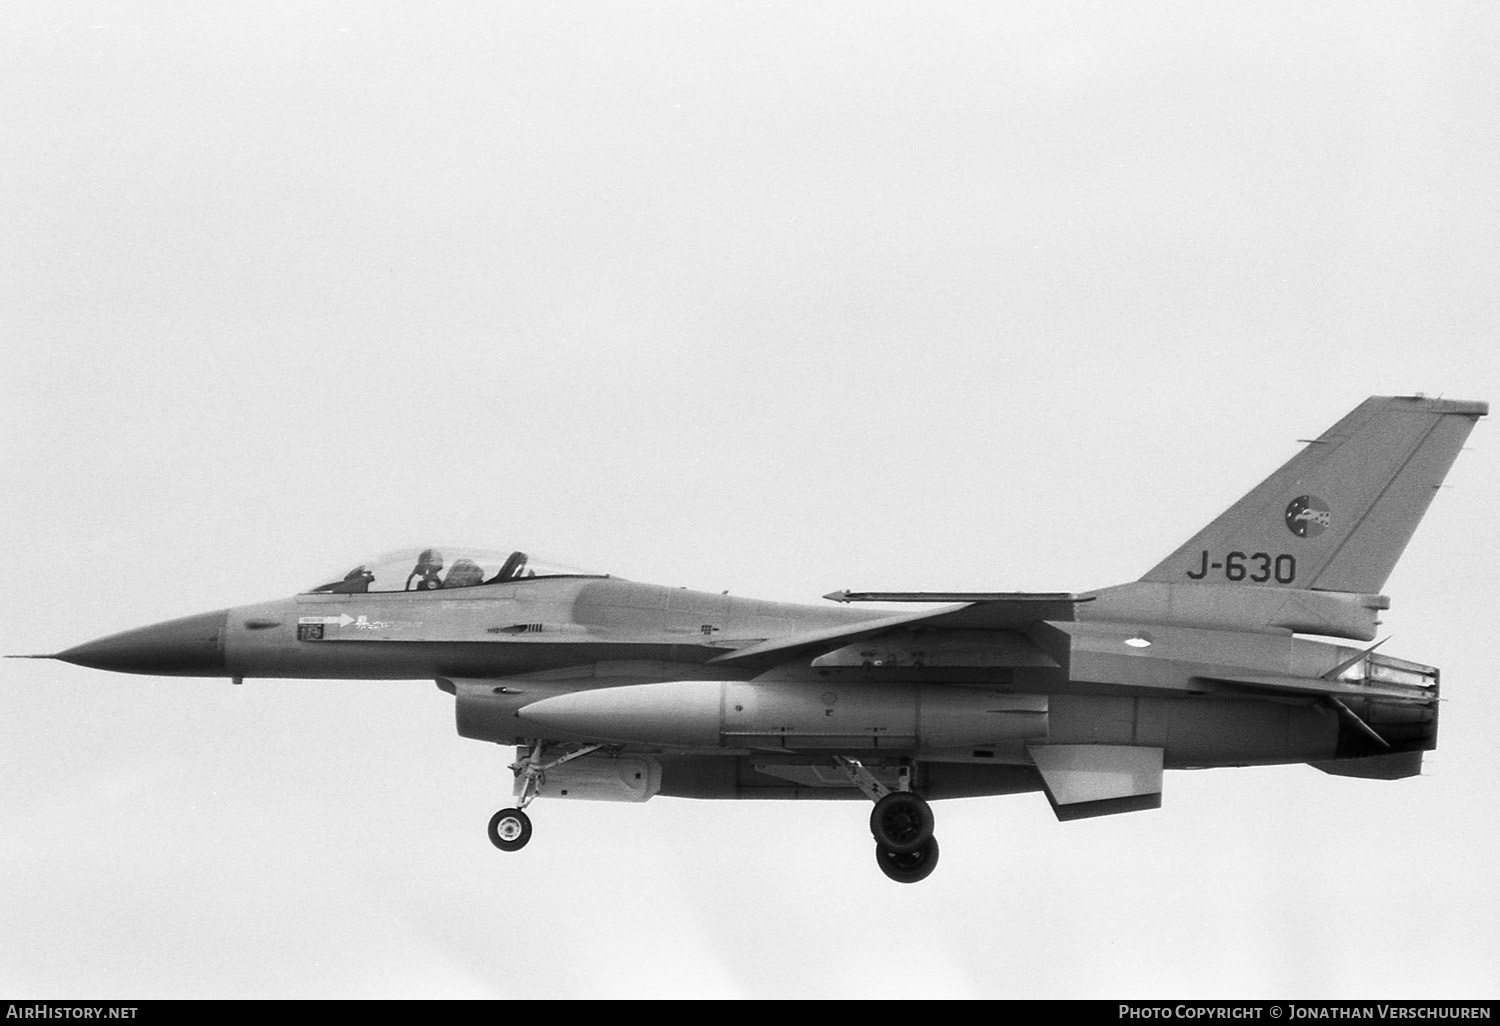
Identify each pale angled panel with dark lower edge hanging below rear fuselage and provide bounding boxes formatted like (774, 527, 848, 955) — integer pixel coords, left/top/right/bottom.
(1028, 744, 1164, 822)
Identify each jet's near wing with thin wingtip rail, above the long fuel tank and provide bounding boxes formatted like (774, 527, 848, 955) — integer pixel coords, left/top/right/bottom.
(708, 591, 1092, 666)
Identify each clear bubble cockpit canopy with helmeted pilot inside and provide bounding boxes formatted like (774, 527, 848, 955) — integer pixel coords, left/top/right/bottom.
(305, 545, 605, 594)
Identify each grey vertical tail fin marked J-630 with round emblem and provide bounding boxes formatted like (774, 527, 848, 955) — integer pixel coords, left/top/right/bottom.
(1142, 396, 1490, 594)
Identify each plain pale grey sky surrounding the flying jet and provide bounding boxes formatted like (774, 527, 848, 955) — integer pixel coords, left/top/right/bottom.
(0, 0, 1500, 998)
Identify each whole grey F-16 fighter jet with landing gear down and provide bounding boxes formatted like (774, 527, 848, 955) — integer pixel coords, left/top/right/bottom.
(23, 396, 1488, 884)
